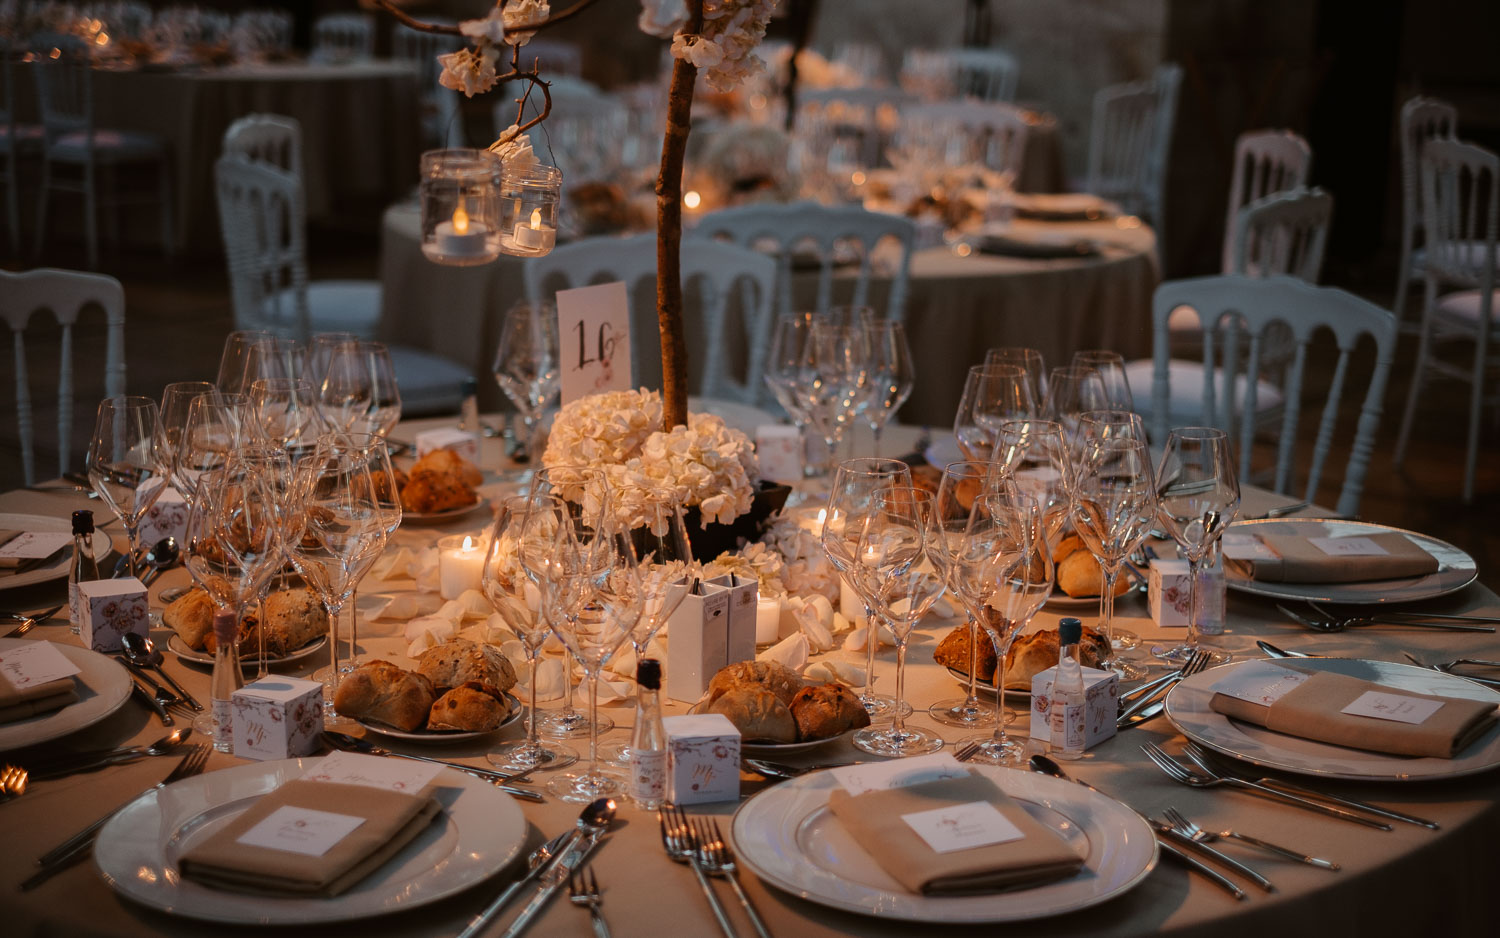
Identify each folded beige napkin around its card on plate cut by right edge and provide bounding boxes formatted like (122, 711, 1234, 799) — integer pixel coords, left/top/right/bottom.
(1209, 671, 1497, 759)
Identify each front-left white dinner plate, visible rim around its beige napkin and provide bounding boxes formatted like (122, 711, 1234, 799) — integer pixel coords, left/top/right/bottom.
(95, 758, 527, 924)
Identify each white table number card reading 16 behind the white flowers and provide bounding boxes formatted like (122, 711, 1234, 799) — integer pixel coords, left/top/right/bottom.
(558, 281, 632, 404)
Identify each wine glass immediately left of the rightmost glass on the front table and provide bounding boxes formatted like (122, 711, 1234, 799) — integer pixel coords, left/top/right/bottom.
(1073, 437, 1157, 680)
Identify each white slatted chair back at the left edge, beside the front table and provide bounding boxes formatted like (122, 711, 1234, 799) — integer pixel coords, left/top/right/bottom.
(0, 267, 125, 485)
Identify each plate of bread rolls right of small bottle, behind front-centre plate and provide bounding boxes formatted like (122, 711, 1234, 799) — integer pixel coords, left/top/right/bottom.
(693, 660, 870, 756)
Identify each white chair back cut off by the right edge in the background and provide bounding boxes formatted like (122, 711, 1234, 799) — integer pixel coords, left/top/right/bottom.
(1422, 138, 1500, 291)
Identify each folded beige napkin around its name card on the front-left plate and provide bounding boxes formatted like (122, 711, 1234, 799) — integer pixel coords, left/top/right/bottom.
(180, 779, 440, 896)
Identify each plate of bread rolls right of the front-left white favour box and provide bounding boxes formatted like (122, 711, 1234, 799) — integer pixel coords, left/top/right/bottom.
(333, 638, 522, 743)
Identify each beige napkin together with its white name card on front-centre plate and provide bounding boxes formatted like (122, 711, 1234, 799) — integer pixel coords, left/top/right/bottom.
(828, 771, 1085, 896)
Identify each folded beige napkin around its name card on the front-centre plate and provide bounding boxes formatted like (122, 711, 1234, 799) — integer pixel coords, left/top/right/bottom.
(828, 771, 1083, 896)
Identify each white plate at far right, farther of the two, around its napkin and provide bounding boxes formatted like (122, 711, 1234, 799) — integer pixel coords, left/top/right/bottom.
(1224, 518, 1479, 605)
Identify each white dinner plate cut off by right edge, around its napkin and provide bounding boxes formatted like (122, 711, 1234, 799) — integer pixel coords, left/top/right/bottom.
(1167, 657, 1500, 782)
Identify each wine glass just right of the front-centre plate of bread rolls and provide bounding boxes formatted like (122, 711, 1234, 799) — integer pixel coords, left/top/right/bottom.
(854, 486, 947, 758)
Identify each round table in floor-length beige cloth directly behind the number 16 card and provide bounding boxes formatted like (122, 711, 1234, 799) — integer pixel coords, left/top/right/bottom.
(378, 208, 1160, 426)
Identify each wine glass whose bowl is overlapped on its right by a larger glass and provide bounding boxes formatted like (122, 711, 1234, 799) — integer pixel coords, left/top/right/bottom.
(927, 459, 1005, 726)
